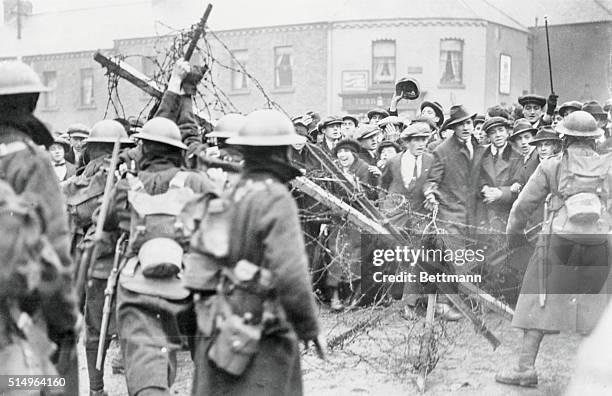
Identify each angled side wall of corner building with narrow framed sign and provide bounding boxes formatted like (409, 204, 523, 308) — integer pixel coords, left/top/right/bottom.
(478, 23, 531, 113)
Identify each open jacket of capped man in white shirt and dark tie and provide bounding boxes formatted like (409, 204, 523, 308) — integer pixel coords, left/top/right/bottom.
(381, 153, 434, 217)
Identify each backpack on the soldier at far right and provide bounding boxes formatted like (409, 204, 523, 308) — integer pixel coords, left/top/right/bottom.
(550, 150, 612, 245)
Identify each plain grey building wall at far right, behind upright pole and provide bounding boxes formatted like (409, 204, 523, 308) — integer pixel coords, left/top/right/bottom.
(532, 22, 612, 103)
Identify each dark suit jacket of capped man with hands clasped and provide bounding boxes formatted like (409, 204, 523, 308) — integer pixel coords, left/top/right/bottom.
(478, 144, 523, 232)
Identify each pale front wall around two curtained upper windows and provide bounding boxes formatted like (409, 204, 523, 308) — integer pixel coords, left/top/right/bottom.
(330, 20, 486, 115)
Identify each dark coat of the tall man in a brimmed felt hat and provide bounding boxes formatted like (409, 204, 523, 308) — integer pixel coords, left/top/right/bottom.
(423, 135, 484, 234)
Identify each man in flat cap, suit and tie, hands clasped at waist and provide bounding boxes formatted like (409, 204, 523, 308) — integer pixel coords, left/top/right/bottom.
(478, 117, 522, 232)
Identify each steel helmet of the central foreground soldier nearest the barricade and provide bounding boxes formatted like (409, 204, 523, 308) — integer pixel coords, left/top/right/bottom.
(227, 109, 306, 146)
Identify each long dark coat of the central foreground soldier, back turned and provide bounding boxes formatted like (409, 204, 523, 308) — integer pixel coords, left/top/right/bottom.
(192, 172, 319, 396)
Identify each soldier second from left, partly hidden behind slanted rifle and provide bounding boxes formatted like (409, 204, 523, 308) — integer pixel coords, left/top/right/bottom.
(63, 120, 133, 396)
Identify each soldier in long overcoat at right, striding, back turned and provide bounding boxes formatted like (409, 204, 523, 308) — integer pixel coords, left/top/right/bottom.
(495, 111, 612, 387)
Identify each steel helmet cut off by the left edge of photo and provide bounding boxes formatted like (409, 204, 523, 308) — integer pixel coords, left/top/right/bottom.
(0, 61, 49, 95)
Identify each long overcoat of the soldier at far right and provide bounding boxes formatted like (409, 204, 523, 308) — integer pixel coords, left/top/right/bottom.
(506, 145, 612, 333)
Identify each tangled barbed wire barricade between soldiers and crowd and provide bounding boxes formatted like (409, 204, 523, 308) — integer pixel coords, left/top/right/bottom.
(99, 19, 520, 386)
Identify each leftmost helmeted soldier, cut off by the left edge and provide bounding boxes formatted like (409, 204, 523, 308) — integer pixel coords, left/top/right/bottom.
(0, 62, 78, 395)
